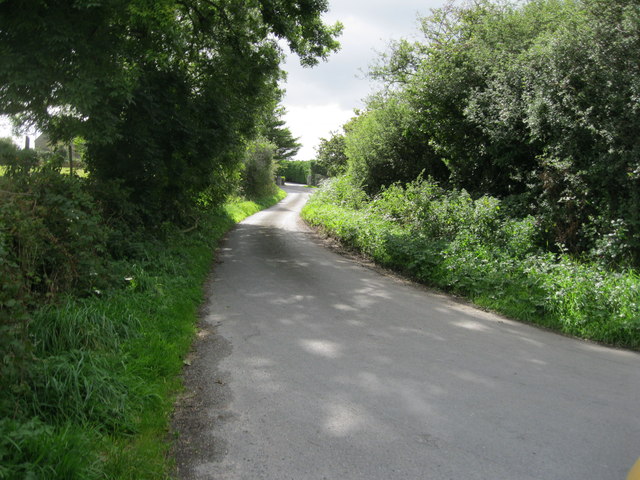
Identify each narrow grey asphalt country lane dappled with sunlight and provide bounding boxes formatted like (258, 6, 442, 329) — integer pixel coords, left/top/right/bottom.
(175, 186, 640, 480)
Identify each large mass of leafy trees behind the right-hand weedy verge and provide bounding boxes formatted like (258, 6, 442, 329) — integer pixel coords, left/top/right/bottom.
(345, 0, 640, 268)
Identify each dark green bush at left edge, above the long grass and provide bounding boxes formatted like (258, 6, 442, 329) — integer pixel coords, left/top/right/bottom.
(0, 157, 108, 296)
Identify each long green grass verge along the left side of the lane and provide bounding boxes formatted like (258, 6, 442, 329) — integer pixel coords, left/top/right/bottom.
(0, 191, 284, 480)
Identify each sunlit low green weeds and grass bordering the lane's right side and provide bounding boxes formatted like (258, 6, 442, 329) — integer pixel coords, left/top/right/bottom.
(302, 178, 640, 349)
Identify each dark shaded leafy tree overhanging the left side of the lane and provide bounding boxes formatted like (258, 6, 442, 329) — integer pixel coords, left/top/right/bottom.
(0, 0, 341, 223)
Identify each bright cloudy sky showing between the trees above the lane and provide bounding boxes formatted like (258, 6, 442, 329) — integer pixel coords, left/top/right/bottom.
(283, 0, 444, 160)
